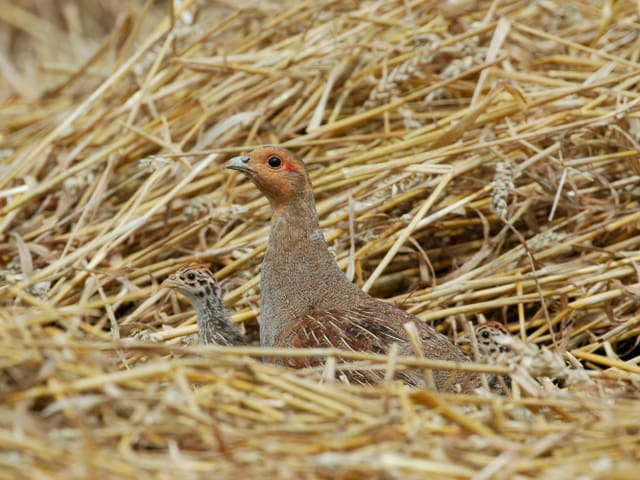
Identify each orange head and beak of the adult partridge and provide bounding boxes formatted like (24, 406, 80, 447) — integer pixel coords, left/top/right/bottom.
(226, 147, 311, 209)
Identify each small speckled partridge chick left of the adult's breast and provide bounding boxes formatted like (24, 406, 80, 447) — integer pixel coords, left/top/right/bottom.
(161, 263, 247, 346)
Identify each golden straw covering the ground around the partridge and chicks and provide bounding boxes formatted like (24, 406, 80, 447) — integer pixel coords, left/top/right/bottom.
(0, 0, 640, 479)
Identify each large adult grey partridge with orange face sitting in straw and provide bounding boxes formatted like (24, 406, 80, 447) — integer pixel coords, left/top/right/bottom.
(226, 146, 481, 392)
